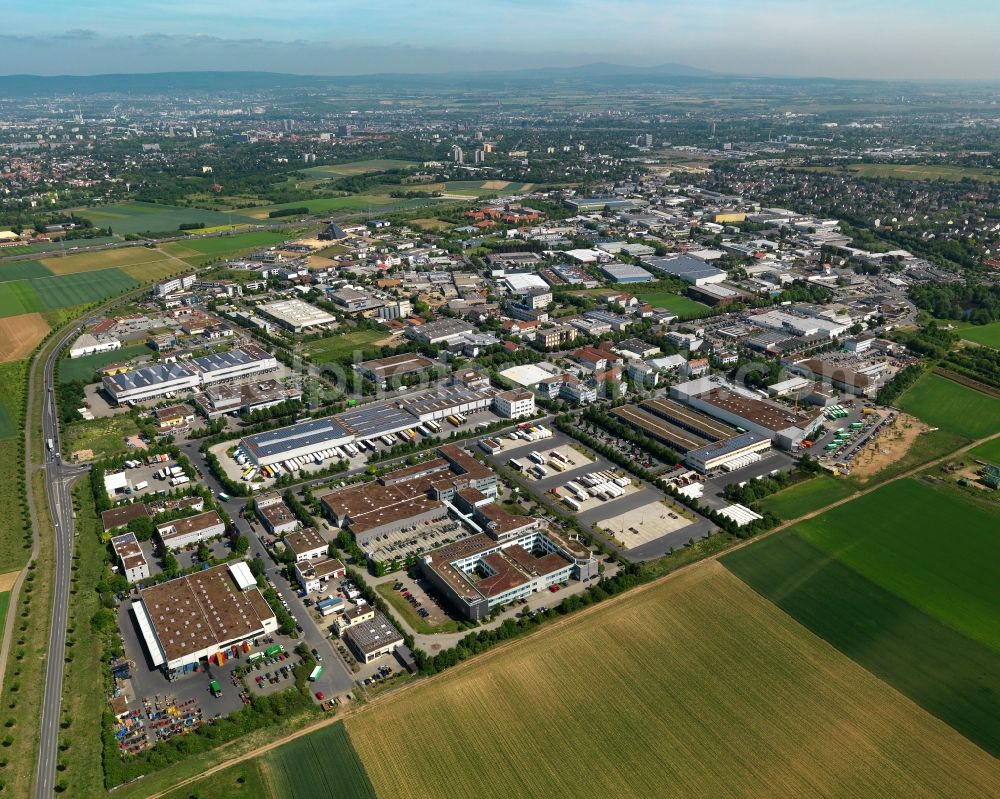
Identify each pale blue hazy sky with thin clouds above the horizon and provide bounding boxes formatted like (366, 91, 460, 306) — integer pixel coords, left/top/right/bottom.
(0, 0, 1000, 80)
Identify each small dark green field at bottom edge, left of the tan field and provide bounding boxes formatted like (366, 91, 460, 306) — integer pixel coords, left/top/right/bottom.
(262, 722, 375, 799)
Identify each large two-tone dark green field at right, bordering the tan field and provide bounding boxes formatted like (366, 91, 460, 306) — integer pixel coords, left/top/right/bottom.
(722, 478, 1000, 755)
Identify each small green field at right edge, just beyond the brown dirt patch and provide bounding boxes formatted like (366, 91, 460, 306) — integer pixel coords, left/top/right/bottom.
(898, 372, 1000, 439)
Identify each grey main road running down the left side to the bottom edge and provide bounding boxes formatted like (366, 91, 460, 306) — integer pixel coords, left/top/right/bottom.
(34, 325, 87, 799)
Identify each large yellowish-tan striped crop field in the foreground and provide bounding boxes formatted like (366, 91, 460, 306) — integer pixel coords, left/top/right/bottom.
(348, 562, 1000, 799)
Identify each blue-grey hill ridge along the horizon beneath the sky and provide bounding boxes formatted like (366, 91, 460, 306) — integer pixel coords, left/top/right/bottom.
(0, 63, 718, 97)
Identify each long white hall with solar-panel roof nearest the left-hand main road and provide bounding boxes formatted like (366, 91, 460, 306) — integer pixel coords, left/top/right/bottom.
(103, 344, 278, 405)
